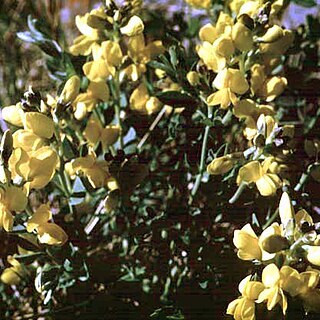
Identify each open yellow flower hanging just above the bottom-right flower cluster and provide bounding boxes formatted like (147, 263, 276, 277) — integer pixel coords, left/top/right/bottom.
(237, 157, 281, 196)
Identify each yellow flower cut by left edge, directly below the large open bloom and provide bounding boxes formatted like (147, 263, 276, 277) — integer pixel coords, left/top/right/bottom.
(0, 186, 28, 231)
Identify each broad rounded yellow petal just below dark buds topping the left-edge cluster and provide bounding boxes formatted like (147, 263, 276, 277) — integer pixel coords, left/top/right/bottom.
(23, 112, 54, 139)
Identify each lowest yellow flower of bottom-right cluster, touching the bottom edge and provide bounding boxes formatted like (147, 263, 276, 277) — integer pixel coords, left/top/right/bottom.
(227, 275, 264, 320)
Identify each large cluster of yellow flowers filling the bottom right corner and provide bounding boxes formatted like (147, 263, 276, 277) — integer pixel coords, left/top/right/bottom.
(227, 192, 320, 319)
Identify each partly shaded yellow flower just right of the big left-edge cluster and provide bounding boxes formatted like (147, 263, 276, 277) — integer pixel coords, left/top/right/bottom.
(65, 148, 112, 188)
